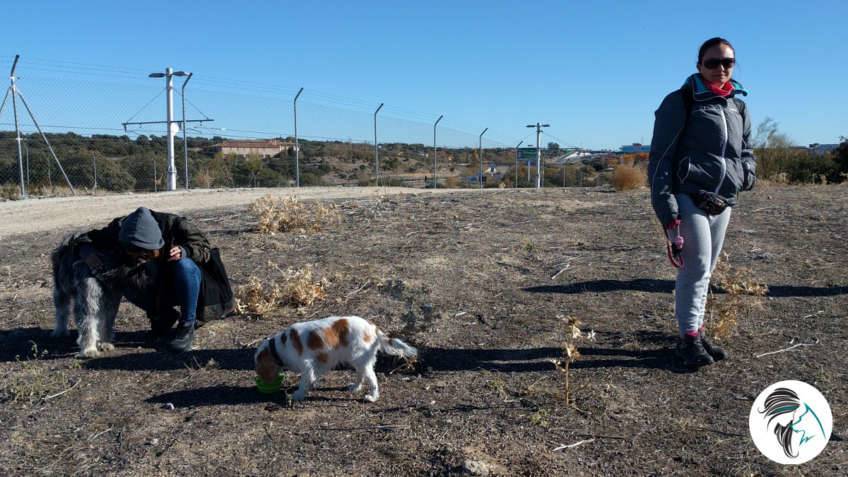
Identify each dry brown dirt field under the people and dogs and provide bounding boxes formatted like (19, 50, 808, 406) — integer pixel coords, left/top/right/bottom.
(0, 186, 848, 476)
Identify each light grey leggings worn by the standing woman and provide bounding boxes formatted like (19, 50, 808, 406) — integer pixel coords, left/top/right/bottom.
(674, 194, 731, 336)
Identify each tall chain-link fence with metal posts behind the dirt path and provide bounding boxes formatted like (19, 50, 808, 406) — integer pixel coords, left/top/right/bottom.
(0, 57, 608, 199)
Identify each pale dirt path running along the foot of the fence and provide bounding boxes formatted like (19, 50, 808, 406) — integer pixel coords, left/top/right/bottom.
(0, 187, 470, 238)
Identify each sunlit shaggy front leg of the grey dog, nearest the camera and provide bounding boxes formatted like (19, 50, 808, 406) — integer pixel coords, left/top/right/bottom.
(74, 262, 103, 358)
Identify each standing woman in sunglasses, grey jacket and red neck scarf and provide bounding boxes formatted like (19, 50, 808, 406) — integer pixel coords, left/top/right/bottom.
(648, 38, 756, 368)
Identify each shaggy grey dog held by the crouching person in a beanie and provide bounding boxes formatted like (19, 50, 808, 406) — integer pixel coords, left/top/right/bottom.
(50, 235, 155, 358)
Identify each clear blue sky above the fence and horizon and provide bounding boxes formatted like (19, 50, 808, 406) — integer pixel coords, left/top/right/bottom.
(0, 0, 848, 148)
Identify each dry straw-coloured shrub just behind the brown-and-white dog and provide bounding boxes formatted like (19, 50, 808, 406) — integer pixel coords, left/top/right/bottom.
(236, 266, 329, 316)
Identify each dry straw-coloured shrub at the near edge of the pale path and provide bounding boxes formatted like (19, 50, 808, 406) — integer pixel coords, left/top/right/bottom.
(248, 195, 341, 235)
